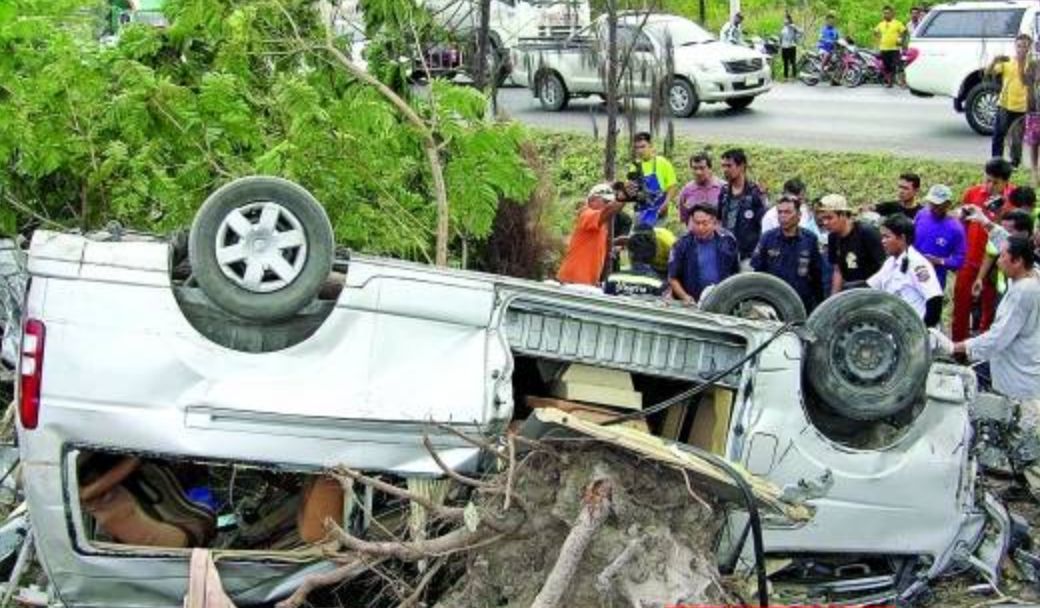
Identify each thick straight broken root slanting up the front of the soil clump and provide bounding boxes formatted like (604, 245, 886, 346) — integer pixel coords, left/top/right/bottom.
(530, 478, 610, 608)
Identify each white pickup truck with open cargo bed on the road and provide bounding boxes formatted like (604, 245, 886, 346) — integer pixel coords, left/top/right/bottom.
(511, 14, 772, 117)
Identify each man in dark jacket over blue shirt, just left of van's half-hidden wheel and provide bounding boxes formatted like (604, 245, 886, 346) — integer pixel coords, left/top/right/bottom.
(668, 205, 740, 303)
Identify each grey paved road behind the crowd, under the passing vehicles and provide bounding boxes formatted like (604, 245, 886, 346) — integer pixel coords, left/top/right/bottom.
(499, 83, 989, 162)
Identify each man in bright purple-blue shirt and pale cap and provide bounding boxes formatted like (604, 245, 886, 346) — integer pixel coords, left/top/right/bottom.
(913, 184, 967, 289)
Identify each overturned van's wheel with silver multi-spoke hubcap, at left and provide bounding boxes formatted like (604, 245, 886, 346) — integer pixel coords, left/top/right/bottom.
(188, 176, 334, 321)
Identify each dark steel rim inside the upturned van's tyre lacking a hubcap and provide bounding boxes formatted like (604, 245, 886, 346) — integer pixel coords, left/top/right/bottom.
(833, 323, 899, 386)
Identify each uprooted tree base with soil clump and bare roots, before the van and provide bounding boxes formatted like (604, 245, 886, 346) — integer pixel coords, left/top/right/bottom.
(279, 441, 731, 608)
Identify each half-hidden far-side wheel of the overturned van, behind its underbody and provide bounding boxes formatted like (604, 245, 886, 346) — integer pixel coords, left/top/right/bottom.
(700, 272, 805, 323)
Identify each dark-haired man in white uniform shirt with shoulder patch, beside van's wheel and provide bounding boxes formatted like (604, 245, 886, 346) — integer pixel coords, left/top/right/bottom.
(866, 214, 942, 327)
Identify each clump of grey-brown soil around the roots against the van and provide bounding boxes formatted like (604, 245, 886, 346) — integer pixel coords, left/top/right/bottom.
(437, 444, 735, 608)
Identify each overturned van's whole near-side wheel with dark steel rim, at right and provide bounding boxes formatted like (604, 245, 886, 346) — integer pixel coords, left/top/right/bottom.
(805, 289, 932, 420)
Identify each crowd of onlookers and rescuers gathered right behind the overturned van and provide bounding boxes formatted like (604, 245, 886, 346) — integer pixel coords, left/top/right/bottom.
(557, 133, 1040, 436)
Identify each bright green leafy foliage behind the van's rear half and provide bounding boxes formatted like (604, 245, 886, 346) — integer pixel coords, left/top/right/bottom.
(0, 0, 534, 259)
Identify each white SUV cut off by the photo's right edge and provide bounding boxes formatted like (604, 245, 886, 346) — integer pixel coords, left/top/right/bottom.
(906, 0, 1037, 135)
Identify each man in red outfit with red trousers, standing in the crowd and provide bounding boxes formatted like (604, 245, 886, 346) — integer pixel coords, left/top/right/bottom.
(951, 158, 1014, 342)
